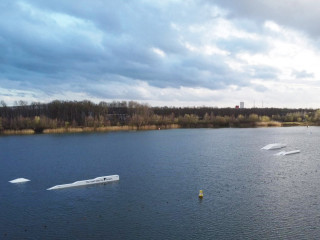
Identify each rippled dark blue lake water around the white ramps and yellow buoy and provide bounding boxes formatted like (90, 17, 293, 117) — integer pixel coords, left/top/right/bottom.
(0, 127, 320, 239)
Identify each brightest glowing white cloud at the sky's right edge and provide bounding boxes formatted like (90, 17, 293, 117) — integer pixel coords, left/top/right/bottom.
(237, 22, 320, 81)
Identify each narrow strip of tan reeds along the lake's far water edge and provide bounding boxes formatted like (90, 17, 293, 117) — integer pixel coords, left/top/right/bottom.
(0, 121, 314, 137)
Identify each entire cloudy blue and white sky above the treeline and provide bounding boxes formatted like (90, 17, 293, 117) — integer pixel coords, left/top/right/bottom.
(0, 0, 320, 108)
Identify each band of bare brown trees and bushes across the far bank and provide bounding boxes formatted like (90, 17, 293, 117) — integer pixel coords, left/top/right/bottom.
(0, 100, 320, 133)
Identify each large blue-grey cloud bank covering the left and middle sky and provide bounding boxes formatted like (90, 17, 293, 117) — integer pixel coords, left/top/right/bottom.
(0, 0, 288, 102)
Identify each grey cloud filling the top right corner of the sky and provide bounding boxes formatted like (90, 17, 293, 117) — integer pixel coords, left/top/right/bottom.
(212, 0, 320, 37)
